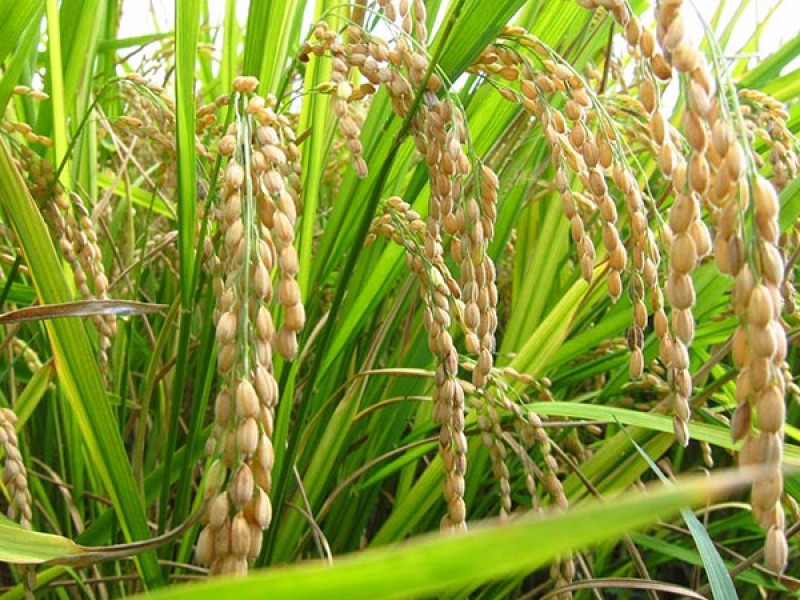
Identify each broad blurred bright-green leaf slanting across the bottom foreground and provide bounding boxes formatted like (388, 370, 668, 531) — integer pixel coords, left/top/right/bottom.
(139, 474, 743, 600)
